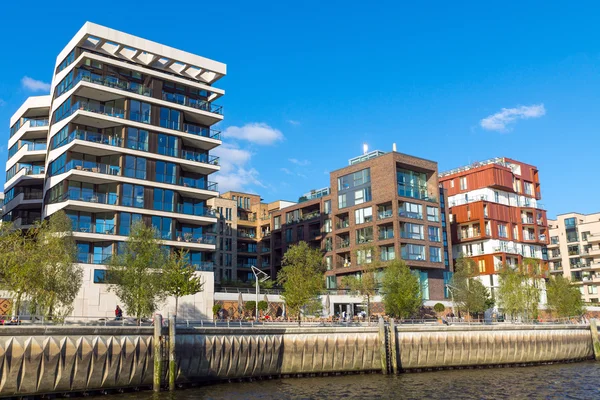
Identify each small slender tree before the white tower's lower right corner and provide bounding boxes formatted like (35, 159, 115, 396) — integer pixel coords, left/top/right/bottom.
(162, 250, 203, 316)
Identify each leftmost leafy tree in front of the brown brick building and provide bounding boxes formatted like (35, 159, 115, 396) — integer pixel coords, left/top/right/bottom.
(277, 242, 324, 324)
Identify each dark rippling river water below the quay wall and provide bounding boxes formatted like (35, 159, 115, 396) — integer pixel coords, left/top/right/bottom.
(74, 361, 600, 400)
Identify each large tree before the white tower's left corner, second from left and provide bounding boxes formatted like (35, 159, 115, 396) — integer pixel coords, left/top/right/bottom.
(31, 211, 83, 317)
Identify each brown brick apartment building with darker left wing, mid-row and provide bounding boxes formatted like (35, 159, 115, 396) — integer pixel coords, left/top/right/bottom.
(271, 151, 452, 300)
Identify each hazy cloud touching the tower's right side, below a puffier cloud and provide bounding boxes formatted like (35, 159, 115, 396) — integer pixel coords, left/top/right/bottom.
(212, 144, 266, 193)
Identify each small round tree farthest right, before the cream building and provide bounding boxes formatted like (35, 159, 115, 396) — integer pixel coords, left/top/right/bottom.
(546, 275, 583, 318)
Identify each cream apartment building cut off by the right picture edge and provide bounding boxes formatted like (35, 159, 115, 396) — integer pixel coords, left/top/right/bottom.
(548, 213, 600, 303)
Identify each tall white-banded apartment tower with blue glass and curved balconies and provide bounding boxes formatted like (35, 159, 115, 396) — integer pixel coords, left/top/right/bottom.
(3, 22, 226, 316)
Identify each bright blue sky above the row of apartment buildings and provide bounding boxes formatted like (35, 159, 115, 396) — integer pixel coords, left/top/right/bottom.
(0, 0, 600, 216)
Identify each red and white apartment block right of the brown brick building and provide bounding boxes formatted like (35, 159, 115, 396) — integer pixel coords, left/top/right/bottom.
(439, 158, 548, 293)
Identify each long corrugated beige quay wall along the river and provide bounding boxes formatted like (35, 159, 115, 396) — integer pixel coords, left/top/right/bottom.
(0, 324, 594, 397)
